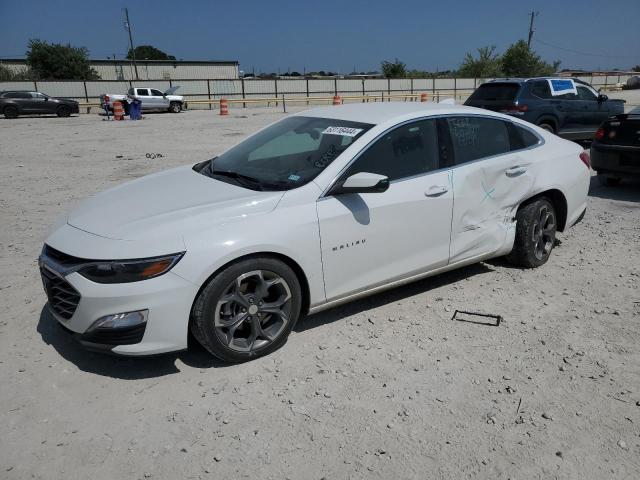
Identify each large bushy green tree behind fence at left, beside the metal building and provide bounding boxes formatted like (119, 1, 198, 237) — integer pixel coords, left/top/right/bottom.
(27, 39, 100, 80)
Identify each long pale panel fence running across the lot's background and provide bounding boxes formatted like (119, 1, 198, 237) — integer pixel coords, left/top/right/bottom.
(0, 75, 629, 108)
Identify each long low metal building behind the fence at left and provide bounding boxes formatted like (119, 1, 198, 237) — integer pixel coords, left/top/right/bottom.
(0, 59, 239, 80)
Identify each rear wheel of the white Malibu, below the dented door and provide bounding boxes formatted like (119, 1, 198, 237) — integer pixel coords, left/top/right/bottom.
(507, 197, 558, 268)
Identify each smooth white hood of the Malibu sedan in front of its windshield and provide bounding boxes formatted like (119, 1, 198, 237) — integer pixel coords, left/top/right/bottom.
(67, 166, 284, 241)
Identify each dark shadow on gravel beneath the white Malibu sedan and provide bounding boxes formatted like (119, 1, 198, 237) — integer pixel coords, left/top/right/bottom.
(37, 263, 493, 380)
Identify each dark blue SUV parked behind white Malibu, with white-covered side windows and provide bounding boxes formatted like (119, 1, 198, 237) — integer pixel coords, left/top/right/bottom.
(464, 77, 624, 140)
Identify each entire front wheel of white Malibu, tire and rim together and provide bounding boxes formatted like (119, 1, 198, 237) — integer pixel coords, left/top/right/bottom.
(190, 257, 302, 363)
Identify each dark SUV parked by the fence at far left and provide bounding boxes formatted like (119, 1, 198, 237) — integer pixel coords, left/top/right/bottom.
(0, 90, 80, 118)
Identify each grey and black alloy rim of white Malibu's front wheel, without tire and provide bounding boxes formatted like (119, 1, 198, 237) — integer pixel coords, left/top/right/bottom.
(214, 270, 291, 353)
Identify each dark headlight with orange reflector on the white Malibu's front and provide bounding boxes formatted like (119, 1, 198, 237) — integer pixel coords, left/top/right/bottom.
(78, 252, 184, 283)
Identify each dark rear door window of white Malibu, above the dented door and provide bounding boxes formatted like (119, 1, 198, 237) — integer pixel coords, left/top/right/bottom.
(447, 116, 511, 165)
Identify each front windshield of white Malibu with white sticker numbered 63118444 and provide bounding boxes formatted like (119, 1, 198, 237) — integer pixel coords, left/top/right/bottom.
(194, 116, 373, 190)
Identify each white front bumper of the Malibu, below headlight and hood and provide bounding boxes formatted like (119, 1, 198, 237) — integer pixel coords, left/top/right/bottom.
(43, 272, 198, 356)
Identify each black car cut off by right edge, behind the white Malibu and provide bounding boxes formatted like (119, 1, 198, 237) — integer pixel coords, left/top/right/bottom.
(591, 107, 640, 186)
